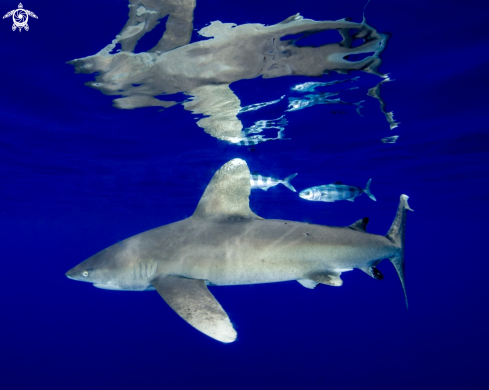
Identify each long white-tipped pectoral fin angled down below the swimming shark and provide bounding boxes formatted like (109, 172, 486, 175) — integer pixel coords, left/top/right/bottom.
(151, 275, 237, 343)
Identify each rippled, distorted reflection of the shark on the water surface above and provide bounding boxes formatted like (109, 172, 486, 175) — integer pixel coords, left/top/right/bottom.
(69, 0, 388, 143)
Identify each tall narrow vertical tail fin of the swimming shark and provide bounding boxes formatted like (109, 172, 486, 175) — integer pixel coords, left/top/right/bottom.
(386, 195, 414, 308)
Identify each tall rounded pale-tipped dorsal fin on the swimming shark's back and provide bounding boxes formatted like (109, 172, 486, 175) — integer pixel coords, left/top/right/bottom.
(193, 158, 262, 219)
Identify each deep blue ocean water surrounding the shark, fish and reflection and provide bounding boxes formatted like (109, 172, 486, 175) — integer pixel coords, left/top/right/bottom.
(0, 0, 489, 389)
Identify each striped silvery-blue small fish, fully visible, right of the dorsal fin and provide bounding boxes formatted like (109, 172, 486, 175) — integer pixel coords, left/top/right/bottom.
(299, 179, 377, 202)
